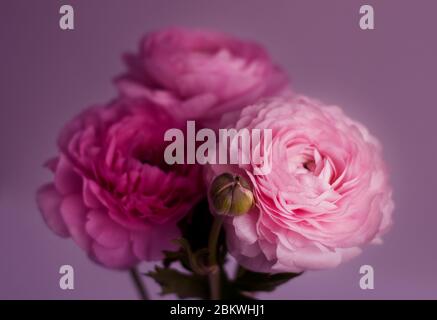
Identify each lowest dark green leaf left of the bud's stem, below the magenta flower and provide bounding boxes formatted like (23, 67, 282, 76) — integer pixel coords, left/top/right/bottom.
(147, 267, 209, 299)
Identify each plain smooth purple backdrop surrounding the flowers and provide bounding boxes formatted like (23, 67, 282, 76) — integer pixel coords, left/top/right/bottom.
(0, 0, 437, 299)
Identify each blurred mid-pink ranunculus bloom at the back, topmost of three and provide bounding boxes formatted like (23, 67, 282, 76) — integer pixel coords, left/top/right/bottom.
(116, 28, 289, 123)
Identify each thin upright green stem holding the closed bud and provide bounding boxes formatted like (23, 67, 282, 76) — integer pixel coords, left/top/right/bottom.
(208, 217, 223, 300)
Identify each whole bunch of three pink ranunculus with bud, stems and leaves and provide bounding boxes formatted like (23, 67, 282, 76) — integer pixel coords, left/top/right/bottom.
(37, 28, 394, 299)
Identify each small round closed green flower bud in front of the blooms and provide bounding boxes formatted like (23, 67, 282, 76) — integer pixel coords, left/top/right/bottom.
(209, 173, 254, 216)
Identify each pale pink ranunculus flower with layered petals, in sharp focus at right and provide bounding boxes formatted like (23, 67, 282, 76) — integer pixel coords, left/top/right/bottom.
(207, 96, 394, 272)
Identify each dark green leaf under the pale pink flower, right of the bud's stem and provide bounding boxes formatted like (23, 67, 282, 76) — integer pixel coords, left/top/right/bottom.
(234, 266, 302, 292)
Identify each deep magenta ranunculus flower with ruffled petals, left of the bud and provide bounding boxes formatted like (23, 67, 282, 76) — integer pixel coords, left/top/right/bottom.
(37, 99, 203, 269)
